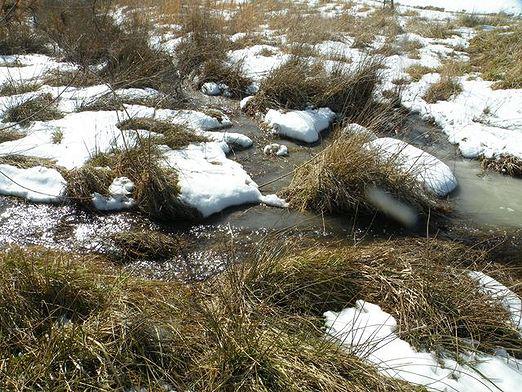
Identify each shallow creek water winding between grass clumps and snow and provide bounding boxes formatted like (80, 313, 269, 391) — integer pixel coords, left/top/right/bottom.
(0, 101, 522, 279)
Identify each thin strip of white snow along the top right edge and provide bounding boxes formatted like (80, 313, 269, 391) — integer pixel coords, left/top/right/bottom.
(397, 0, 522, 14)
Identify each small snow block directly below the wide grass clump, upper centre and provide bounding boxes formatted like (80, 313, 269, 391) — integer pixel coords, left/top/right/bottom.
(265, 108, 335, 143)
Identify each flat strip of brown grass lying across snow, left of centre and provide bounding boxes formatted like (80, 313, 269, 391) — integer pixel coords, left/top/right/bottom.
(118, 118, 208, 150)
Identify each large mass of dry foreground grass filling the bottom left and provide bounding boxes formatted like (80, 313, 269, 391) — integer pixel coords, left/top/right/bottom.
(0, 248, 414, 392)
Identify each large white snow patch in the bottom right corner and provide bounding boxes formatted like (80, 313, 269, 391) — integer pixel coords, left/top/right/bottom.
(324, 300, 522, 392)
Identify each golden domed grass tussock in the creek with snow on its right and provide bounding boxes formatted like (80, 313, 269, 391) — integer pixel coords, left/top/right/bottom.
(283, 133, 438, 220)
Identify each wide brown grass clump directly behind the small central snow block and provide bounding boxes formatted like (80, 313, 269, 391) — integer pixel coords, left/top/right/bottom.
(249, 57, 380, 115)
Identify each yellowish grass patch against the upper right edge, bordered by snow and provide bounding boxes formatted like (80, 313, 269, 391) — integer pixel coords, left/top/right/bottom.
(468, 23, 522, 89)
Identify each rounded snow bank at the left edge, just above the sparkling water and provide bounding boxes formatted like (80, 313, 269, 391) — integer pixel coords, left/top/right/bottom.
(0, 164, 66, 203)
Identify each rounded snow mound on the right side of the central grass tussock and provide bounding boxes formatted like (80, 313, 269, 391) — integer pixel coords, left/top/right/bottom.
(365, 137, 457, 197)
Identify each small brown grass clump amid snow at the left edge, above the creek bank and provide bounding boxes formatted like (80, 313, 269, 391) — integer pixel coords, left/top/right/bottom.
(3, 94, 63, 126)
